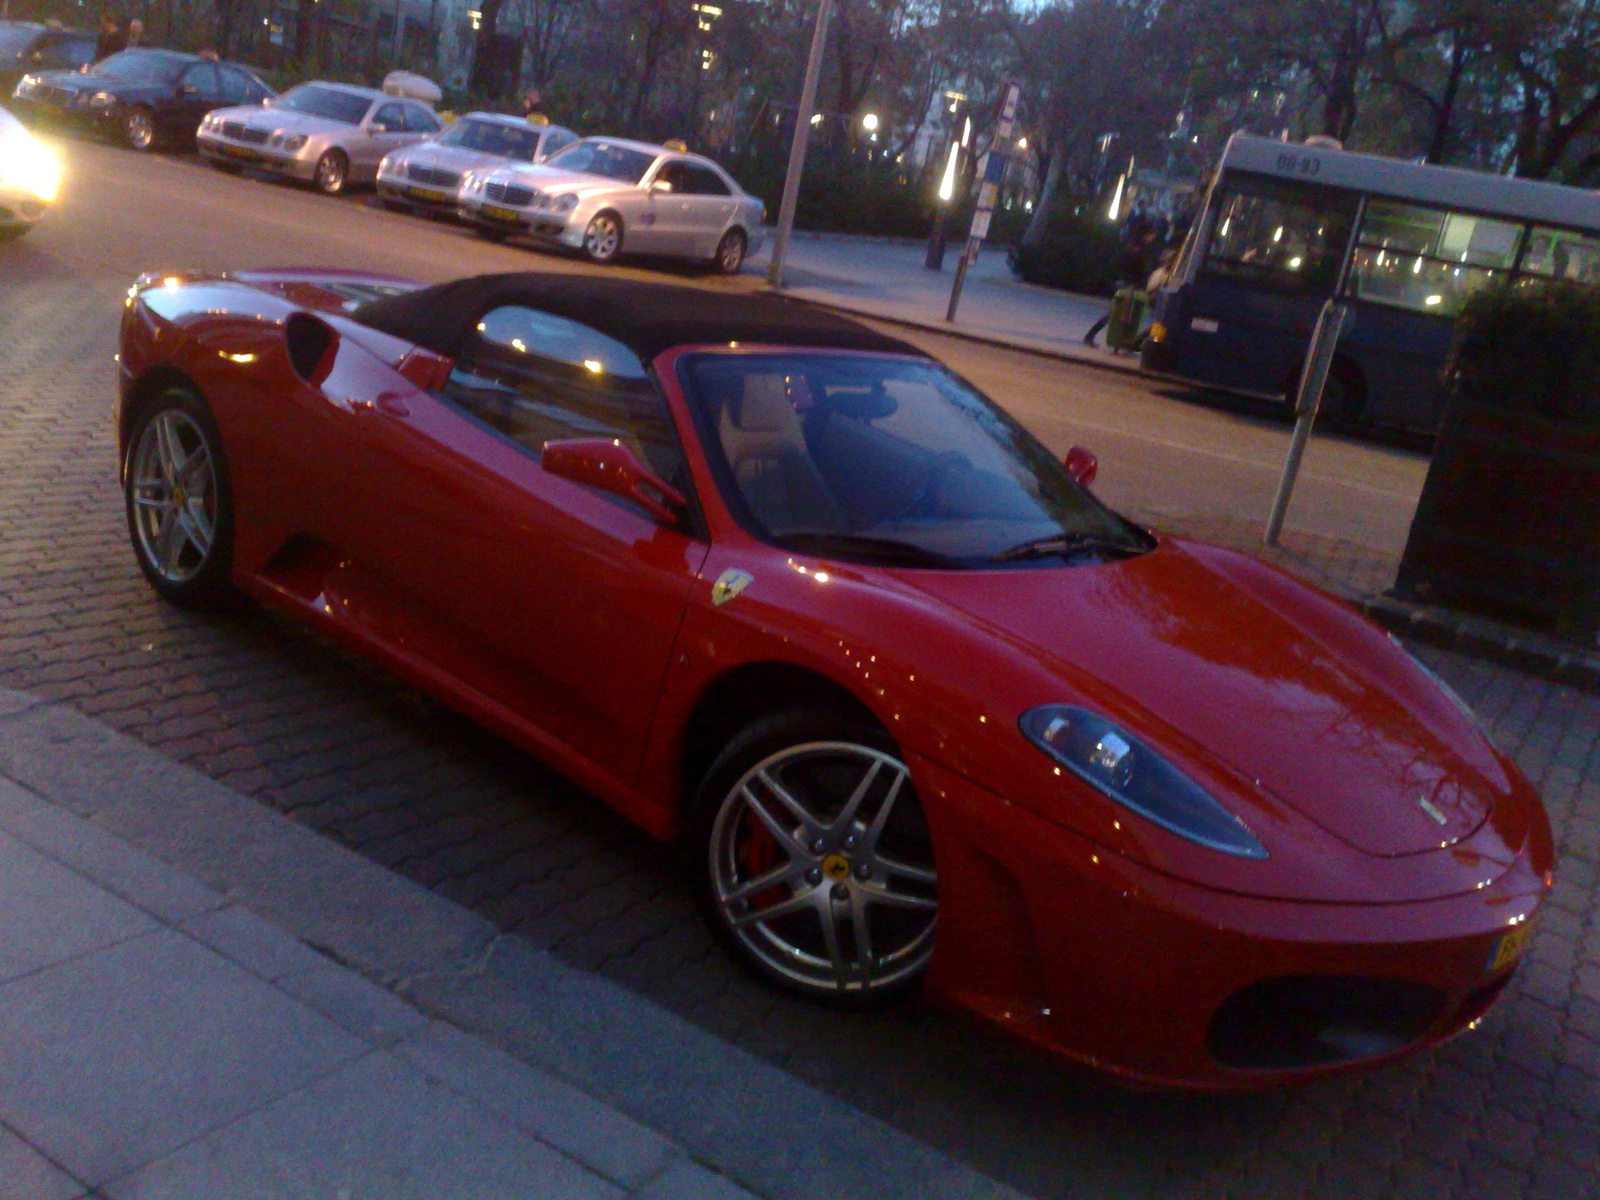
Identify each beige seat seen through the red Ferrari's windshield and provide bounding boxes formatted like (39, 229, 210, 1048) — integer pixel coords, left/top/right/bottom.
(717, 374, 845, 534)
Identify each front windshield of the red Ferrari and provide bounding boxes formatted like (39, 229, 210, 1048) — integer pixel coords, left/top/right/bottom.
(682, 354, 1150, 568)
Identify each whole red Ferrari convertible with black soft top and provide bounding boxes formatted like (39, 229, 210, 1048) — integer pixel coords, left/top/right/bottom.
(118, 270, 1552, 1088)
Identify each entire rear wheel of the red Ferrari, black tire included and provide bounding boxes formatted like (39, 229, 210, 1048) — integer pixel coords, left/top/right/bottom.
(122, 387, 235, 610)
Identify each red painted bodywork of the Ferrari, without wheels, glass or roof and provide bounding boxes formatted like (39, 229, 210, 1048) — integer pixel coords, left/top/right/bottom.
(120, 272, 1552, 1088)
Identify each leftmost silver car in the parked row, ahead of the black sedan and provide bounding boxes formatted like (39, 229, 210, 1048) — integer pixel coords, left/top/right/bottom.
(195, 83, 445, 195)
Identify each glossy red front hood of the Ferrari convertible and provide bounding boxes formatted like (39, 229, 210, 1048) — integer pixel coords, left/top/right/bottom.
(918, 542, 1510, 858)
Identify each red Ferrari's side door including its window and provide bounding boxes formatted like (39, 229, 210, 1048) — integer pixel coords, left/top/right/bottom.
(347, 306, 707, 779)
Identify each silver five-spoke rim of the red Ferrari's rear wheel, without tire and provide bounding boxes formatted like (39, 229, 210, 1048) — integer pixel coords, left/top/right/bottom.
(128, 408, 218, 584)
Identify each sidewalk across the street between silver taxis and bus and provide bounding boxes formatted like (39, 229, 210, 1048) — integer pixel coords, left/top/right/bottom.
(749, 232, 1139, 373)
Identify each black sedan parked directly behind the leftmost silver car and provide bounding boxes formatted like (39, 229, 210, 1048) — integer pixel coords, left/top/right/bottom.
(16, 48, 274, 150)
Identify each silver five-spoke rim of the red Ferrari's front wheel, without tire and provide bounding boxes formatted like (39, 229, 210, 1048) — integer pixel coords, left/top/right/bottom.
(710, 742, 939, 995)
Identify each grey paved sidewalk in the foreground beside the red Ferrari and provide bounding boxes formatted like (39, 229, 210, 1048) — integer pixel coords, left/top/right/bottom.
(0, 691, 1013, 1200)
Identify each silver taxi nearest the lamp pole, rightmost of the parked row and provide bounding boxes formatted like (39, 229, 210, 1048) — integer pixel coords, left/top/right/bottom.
(461, 138, 766, 275)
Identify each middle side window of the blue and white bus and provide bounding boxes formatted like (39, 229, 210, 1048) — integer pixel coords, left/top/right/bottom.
(1349, 200, 1522, 317)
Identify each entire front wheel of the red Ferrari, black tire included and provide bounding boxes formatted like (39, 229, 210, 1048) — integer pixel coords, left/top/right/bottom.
(688, 709, 938, 1008)
